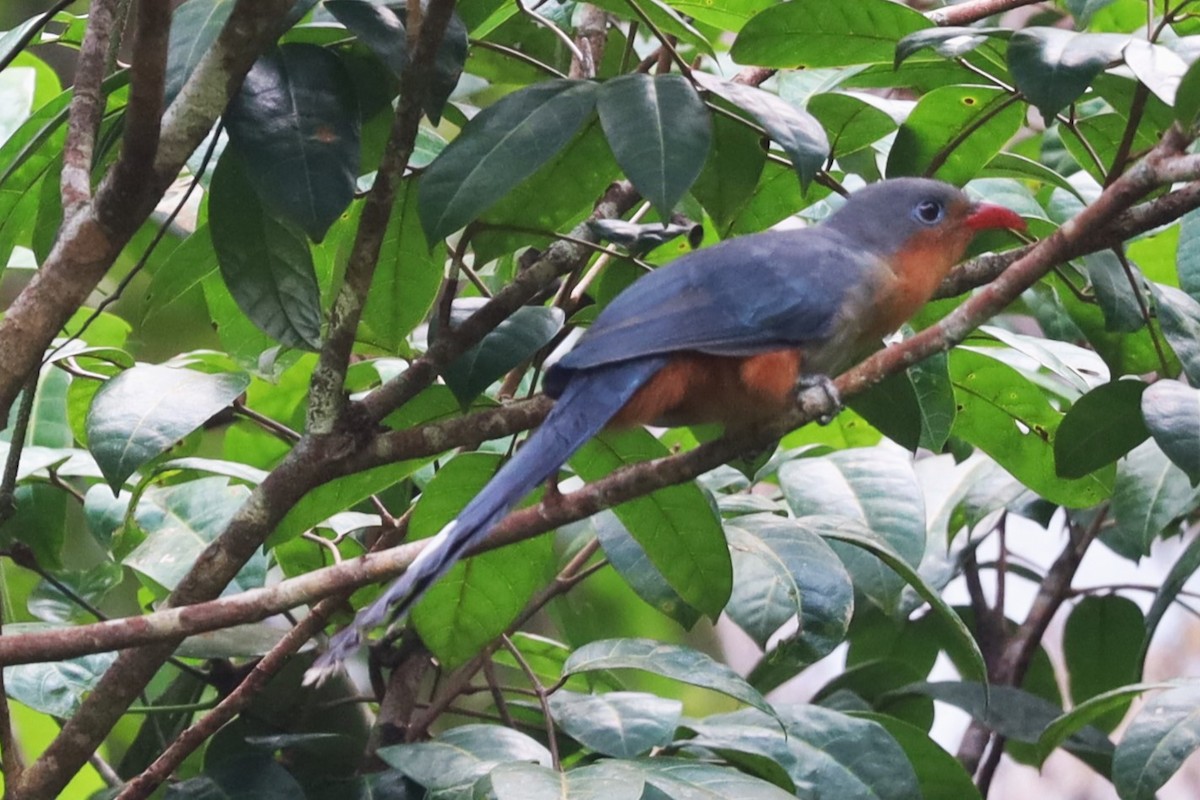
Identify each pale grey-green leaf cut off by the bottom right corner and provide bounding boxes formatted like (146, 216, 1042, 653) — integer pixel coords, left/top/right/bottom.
(1112, 684, 1200, 800)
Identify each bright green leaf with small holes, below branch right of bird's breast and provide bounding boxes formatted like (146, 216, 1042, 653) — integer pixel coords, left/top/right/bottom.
(950, 347, 1112, 507)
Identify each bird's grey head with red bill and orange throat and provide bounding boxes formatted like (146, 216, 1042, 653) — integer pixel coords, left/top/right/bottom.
(824, 178, 1025, 268)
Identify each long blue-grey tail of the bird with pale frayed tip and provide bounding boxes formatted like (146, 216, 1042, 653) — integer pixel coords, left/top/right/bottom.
(305, 357, 666, 684)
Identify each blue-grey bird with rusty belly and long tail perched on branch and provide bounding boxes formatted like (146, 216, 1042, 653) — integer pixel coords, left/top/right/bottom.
(306, 178, 1025, 682)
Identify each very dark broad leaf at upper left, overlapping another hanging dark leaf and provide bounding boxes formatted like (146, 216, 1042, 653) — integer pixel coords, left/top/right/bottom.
(222, 44, 360, 241)
